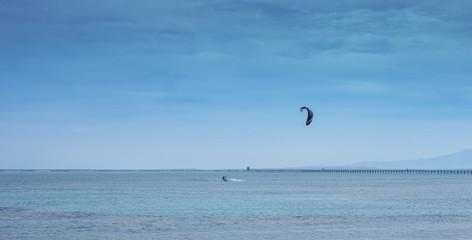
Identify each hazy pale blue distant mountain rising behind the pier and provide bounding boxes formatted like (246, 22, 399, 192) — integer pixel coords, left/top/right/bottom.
(346, 149, 472, 169)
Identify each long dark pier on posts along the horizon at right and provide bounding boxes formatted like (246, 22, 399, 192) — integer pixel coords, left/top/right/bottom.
(250, 169, 472, 174)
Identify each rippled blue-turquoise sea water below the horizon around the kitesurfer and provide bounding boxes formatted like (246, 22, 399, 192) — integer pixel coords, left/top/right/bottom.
(0, 171, 472, 240)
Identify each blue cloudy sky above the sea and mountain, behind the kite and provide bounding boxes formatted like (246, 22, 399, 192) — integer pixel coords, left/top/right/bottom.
(0, 0, 472, 169)
